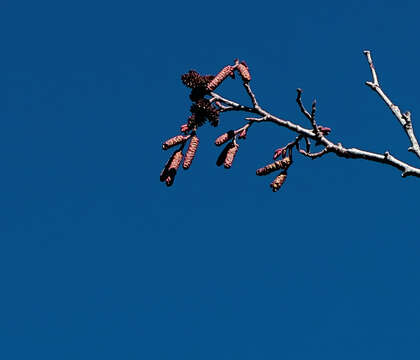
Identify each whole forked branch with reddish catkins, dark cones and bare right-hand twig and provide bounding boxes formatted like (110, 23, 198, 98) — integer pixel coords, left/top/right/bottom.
(161, 50, 420, 191)
